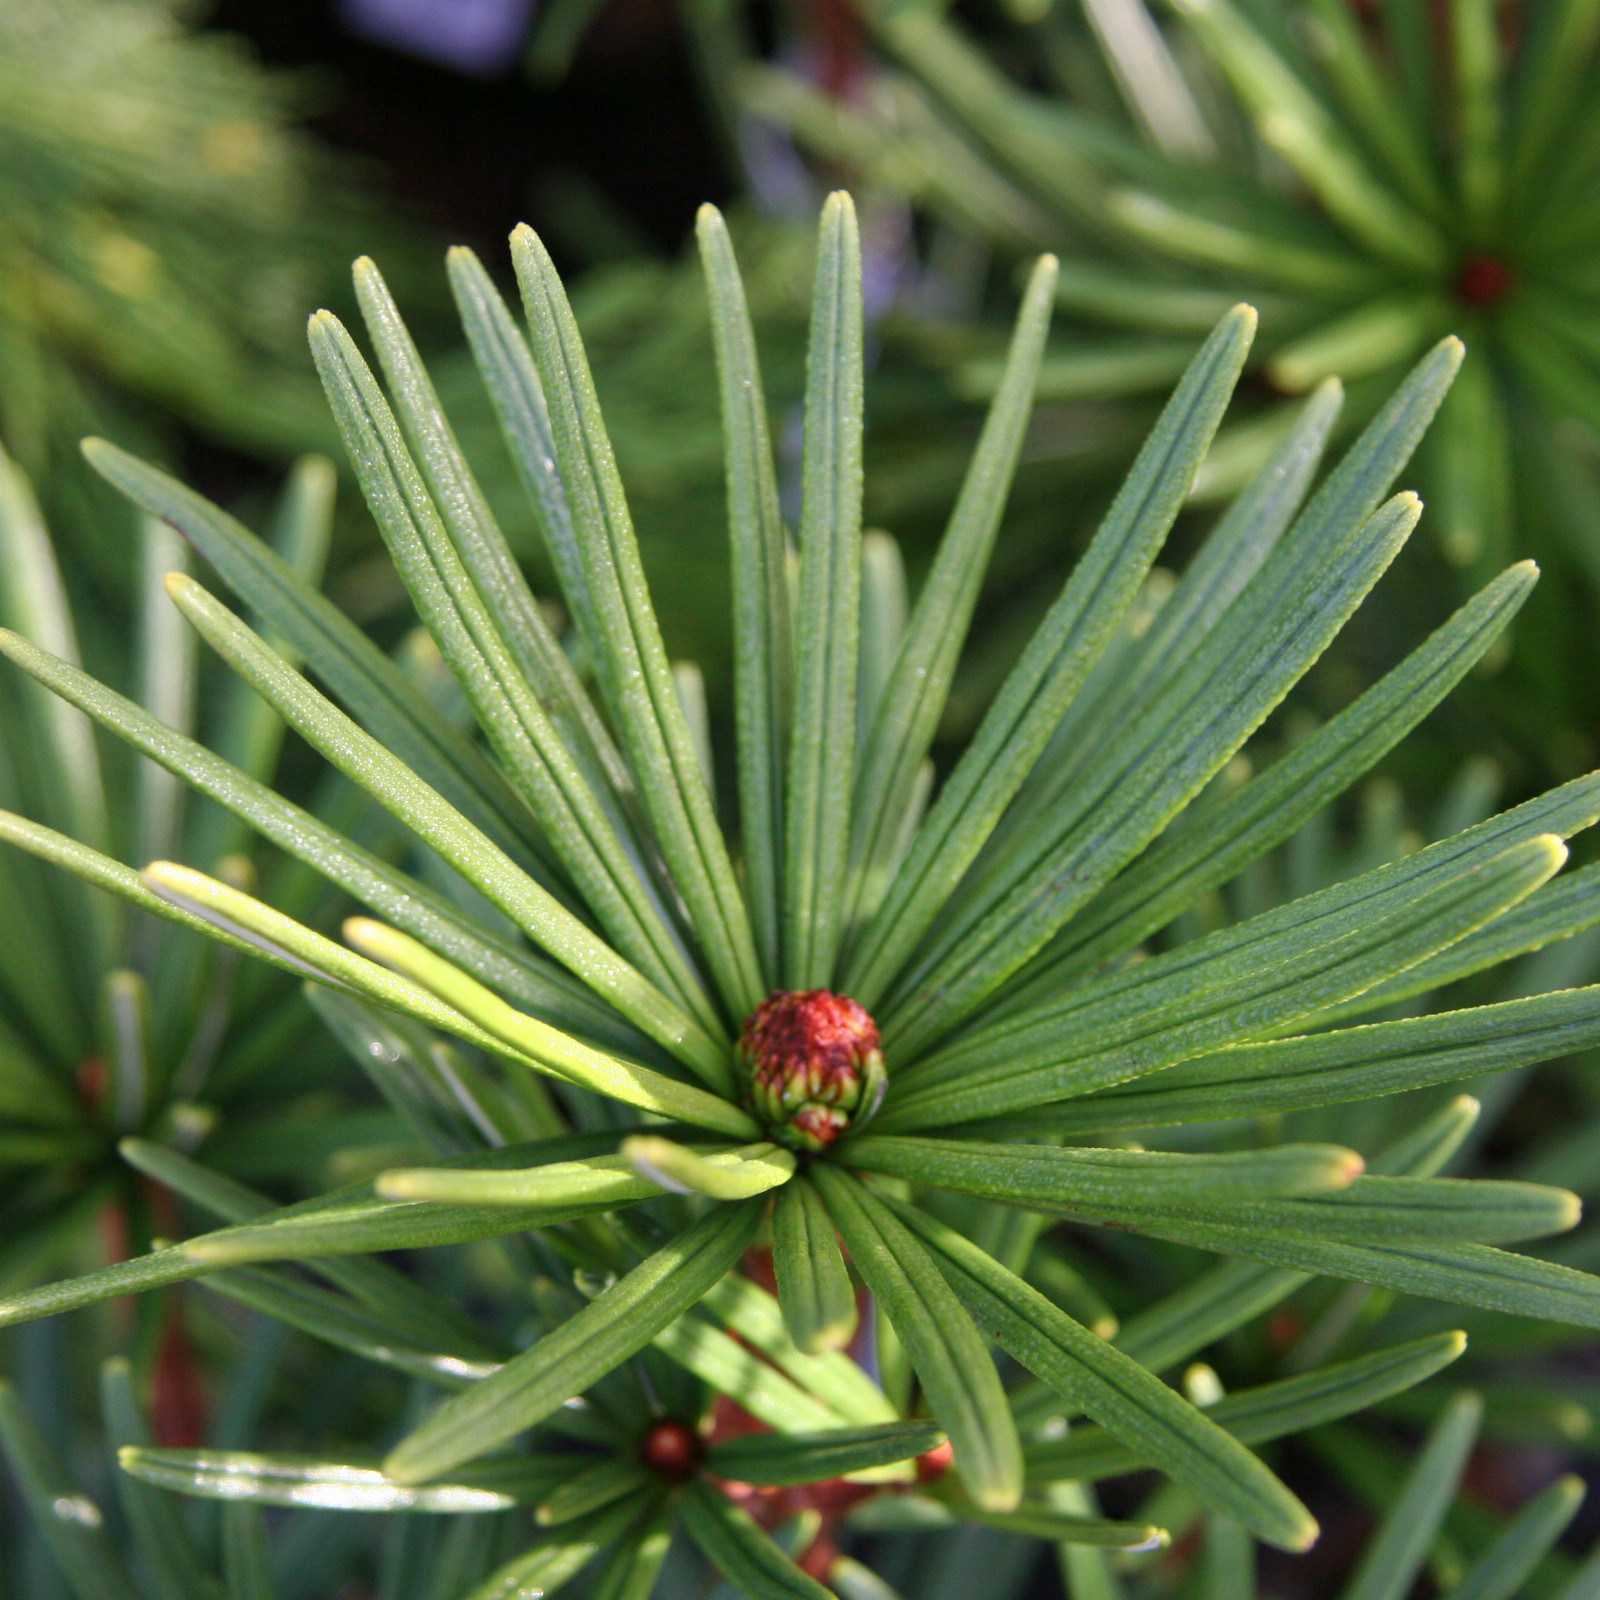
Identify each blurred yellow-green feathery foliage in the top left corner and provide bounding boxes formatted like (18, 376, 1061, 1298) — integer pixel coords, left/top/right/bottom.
(0, 0, 457, 613)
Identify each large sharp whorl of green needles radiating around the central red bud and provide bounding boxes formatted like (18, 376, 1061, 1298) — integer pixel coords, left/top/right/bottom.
(0, 181, 1600, 1595)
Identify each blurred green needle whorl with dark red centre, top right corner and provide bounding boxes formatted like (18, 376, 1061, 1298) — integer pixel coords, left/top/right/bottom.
(738, 0, 1600, 787)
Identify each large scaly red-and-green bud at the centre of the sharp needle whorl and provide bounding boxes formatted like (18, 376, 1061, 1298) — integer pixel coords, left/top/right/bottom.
(739, 989, 886, 1150)
